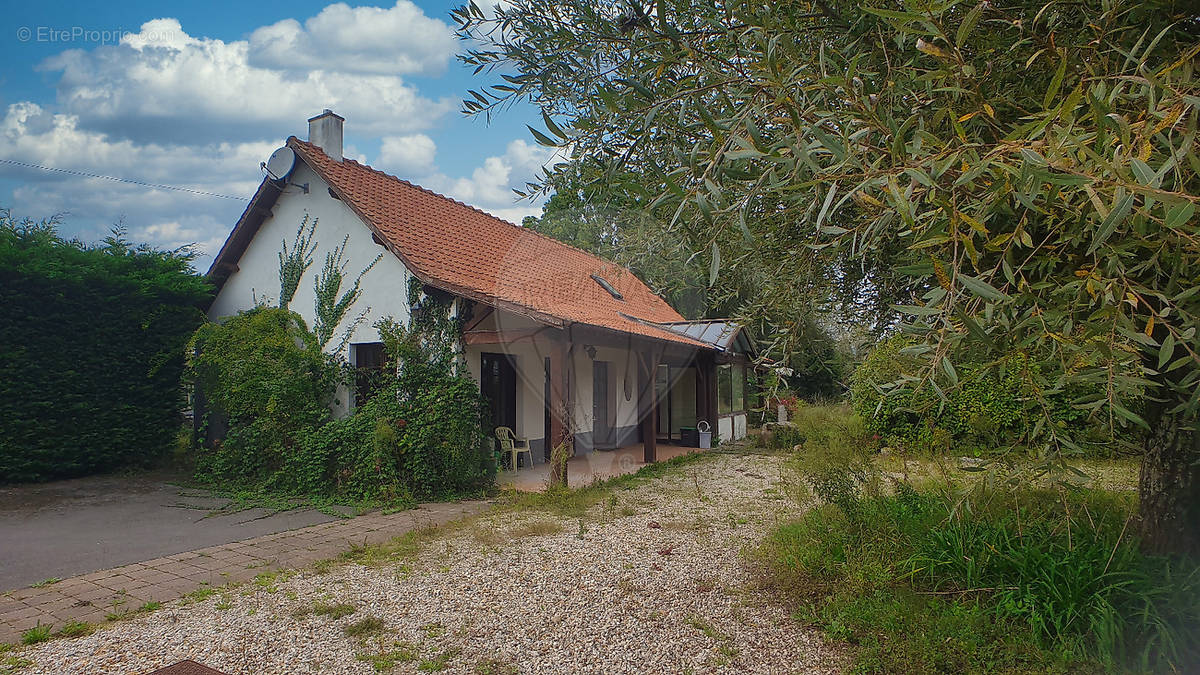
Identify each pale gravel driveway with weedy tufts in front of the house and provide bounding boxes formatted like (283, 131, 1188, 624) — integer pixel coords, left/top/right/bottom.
(9, 453, 841, 674)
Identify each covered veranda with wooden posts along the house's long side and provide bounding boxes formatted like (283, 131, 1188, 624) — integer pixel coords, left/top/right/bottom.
(463, 305, 749, 490)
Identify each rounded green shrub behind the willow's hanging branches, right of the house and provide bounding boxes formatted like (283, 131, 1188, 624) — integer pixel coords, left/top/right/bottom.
(851, 335, 1111, 455)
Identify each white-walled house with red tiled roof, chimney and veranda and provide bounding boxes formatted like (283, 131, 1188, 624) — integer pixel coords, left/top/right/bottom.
(209, 110, 752, 461)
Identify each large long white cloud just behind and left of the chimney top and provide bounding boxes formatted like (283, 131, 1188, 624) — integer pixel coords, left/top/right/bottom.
(40, 18, 456, 143)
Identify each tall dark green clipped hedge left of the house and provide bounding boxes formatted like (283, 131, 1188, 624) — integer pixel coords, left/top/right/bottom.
(0, 211, 210, 483)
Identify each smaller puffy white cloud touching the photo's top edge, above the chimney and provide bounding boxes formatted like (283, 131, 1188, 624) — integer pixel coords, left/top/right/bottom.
(250, 0, 457, 74)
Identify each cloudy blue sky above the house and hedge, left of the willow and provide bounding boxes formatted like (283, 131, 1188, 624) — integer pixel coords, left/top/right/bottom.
(0, 0, 550, 271)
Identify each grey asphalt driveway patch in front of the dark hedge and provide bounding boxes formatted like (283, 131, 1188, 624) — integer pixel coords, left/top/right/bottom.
(0, 474, 348, 592)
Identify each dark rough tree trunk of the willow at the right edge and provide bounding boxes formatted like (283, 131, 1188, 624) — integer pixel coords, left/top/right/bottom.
(1138, 404, 1200, 555)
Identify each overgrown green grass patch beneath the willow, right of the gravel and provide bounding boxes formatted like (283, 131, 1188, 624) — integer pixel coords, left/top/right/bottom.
(756, 406, 1200, 673)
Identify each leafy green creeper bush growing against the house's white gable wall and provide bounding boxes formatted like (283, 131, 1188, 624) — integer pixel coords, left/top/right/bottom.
(190, 289, 494, 503)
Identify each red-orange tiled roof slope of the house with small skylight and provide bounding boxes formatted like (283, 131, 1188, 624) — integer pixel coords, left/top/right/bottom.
(288, 137, 708, 347)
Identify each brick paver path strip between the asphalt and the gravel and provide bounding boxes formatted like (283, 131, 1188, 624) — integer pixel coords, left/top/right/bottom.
(0, 502, 487, 643)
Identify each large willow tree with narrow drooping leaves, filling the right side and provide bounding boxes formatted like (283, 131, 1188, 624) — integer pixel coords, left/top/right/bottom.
(455, 0, 1200, 551)
